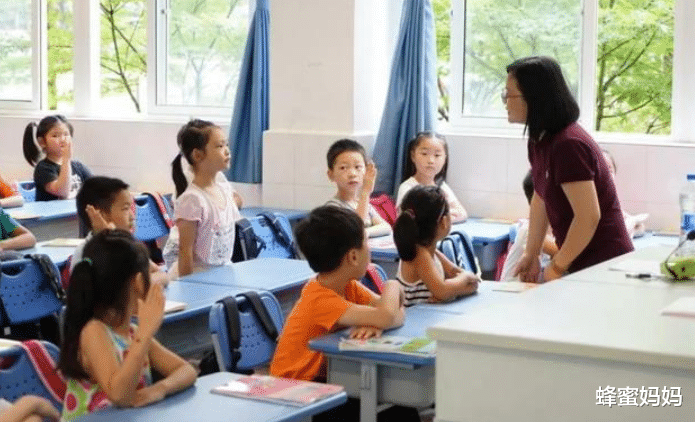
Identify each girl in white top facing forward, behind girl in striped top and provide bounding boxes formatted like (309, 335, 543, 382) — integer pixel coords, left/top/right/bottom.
(396, 132, 468, 223)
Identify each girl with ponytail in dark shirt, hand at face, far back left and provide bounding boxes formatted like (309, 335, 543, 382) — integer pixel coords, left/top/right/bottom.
(22, 114, 92, 201)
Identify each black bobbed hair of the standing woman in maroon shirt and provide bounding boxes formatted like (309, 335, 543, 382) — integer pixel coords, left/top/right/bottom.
(507, 56, 579, 142)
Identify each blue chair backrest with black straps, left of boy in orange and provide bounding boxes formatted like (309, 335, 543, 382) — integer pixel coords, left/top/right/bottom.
(209, 292, 284, 372)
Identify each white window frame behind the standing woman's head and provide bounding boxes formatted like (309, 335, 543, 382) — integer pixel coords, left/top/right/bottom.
(449, 0, 695, 143)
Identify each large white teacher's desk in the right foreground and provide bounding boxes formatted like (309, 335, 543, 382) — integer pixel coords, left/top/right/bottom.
(428, 279, 695, 422)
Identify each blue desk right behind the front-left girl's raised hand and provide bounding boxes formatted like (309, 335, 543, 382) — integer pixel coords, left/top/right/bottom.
(156, 281, 249, 357)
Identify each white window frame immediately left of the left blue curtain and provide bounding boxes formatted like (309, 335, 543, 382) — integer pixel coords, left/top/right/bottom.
(146, 0, 255, 119)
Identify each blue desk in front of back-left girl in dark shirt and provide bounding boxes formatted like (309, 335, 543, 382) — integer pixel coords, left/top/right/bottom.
(7, 199, 80, 241)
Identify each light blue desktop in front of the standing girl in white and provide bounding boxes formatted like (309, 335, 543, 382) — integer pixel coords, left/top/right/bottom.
(180, 258, 316, 317)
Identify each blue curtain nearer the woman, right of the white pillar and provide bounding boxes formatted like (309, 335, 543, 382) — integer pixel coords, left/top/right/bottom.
(372, 0, 437, 194)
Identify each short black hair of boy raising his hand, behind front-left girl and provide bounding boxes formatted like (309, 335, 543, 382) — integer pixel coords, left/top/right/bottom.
(75, 176, 130, 230)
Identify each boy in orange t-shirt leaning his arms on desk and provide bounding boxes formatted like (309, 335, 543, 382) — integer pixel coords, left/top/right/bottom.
(270, 205, 405, 381)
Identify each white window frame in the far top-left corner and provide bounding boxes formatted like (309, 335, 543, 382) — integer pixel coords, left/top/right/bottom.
(0, 0, 48, 111)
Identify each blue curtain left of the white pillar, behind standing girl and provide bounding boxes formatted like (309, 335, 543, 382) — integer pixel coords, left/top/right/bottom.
(227, 0, 270, 183)
